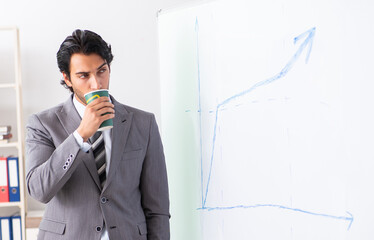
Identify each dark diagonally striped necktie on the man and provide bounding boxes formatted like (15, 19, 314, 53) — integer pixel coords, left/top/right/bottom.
(91, 131, 106, 188)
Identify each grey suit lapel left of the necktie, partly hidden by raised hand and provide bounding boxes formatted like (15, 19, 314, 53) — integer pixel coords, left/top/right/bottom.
(56, 95, 101, 189)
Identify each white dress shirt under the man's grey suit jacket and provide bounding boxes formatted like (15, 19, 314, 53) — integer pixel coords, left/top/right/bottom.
(73, 95, 112, 240)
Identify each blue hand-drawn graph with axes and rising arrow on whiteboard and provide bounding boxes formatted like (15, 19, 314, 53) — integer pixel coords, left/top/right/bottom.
(194, 18, 354, 230)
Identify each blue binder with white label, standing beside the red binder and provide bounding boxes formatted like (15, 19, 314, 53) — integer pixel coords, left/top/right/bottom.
(8, 157, 20, 202)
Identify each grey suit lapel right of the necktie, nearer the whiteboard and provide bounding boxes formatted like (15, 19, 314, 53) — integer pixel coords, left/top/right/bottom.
(103, 97, 133, 191)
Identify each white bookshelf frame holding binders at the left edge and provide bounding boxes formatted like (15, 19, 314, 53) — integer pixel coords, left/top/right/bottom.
(0, 26, 26, 240)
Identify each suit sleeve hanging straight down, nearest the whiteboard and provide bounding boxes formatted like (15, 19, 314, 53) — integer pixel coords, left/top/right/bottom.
(140, 115, 170, 240)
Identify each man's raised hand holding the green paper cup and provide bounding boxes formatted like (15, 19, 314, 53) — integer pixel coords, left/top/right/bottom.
(77, 97, 114, 142)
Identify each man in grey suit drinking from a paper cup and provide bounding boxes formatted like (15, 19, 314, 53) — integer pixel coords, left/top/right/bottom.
(26, 30, 170, 240)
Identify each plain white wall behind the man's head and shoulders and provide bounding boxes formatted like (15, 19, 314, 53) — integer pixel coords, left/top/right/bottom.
(0, 0, 196, 210)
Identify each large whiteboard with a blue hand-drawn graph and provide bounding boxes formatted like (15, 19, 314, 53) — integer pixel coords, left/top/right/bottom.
(158, 0, 374, 240)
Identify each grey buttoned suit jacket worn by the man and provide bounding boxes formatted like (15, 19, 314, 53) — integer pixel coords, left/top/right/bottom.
(26, 95, 170, 240)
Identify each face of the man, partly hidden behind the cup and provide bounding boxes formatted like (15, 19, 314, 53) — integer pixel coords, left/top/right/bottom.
(63, 53, 110, 105)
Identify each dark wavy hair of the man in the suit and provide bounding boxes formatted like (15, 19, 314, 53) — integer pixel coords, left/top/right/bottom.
(57, 29, 113, 92)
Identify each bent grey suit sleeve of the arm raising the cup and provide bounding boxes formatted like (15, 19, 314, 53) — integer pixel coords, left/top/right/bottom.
(26, 115, 88, 203)
